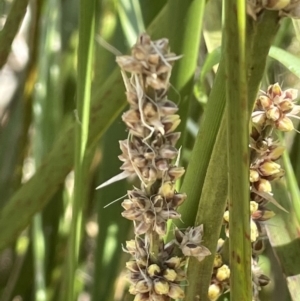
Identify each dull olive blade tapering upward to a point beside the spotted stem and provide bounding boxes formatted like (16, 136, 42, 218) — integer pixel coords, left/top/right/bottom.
(186, 117, 228, 301)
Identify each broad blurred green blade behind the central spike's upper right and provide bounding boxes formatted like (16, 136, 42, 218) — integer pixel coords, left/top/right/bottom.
(167, 0, 206, 149)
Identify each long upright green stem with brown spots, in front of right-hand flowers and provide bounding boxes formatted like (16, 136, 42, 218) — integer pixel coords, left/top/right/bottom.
(225, 0, 252, 301)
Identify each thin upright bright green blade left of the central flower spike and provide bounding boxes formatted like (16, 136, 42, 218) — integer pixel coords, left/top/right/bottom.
(66, 0, 96, 301)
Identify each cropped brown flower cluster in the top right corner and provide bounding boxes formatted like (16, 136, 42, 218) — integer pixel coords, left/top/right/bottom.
(247, 0, 300, 20)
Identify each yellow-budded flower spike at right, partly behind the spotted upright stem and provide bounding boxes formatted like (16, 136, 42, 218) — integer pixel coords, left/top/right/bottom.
(219, 83, 300, 301)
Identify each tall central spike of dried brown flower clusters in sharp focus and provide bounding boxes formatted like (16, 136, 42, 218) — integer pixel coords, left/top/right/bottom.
(112, 34, 210, 301)
